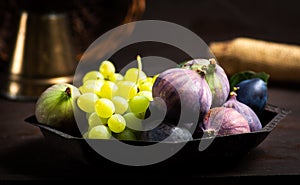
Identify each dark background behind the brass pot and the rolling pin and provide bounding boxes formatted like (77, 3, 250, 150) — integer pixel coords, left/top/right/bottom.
(0, 0, 300, 64)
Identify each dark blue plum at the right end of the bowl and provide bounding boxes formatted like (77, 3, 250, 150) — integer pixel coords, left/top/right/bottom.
(235, 78, 268, 115)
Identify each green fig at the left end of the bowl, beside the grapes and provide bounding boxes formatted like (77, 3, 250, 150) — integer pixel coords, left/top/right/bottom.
(35, 83, 80, 135)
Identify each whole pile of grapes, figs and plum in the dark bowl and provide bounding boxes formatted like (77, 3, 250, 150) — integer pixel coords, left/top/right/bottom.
(35, 56, 268, 142)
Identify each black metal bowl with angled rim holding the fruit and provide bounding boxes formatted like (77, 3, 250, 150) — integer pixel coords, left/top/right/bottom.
(25, 104, 289, 170)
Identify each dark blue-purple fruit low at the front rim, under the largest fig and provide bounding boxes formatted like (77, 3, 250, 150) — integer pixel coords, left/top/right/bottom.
(141, 123, 193, 142)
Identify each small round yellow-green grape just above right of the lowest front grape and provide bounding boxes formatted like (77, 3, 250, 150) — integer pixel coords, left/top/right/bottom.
(107, 114, 126, 133)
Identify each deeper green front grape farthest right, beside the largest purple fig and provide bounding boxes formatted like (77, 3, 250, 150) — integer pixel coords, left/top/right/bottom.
(128, 95, 150, 114)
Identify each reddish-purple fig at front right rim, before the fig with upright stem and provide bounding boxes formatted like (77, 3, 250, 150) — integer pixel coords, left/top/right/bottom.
(202, 107, 250, 136)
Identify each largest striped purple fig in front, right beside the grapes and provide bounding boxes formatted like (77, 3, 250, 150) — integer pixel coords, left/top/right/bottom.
(152, 68, 212, 125)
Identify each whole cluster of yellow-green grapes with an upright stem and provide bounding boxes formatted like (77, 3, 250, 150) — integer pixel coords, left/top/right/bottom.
(77, 56, 157, 140)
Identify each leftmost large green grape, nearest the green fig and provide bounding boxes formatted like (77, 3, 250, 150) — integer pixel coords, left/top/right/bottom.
(77, 93, 98, 113)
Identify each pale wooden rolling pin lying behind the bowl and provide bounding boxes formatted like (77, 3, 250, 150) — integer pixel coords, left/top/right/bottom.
(209, 37, 300, 83)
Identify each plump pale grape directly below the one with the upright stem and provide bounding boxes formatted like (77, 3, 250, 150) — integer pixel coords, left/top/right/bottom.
(116, 81, 138, 100)
